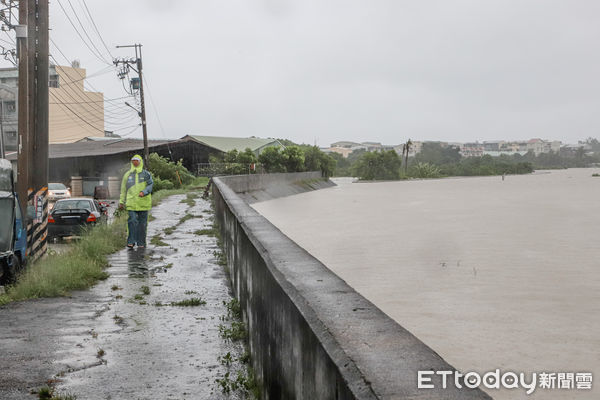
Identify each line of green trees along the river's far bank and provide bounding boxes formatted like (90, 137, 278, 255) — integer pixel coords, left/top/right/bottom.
(210, 138, 600, 180)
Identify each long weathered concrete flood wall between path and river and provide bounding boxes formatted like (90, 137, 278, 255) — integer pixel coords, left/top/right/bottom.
(213, 174, 490, 400)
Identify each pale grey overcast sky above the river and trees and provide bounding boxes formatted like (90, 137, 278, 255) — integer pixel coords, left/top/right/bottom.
(4, 0, 600, 146)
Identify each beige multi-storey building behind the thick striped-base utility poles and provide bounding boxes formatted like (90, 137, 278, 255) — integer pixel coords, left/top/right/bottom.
(0, 63, 105, 151)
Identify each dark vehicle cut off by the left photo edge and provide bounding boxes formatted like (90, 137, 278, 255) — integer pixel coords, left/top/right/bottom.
(0, 159, 27, 284)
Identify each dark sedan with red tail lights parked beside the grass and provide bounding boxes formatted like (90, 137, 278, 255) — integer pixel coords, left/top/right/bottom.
(48, 198, 108, 238)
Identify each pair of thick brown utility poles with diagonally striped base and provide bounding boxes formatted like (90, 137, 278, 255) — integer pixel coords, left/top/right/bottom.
(15, 0, 49, 260)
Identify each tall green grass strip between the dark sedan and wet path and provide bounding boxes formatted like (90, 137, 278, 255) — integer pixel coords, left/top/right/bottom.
(0, 218, 126, 305)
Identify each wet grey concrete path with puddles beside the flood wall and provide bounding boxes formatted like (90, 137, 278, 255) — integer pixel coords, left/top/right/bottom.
(0, 195, 243, 399)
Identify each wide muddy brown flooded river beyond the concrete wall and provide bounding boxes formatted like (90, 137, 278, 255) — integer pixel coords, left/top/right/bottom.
(253, 169, 600, 399)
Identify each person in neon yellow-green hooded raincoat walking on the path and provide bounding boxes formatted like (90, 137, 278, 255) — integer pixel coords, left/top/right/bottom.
(119, 154, 154, 248)
